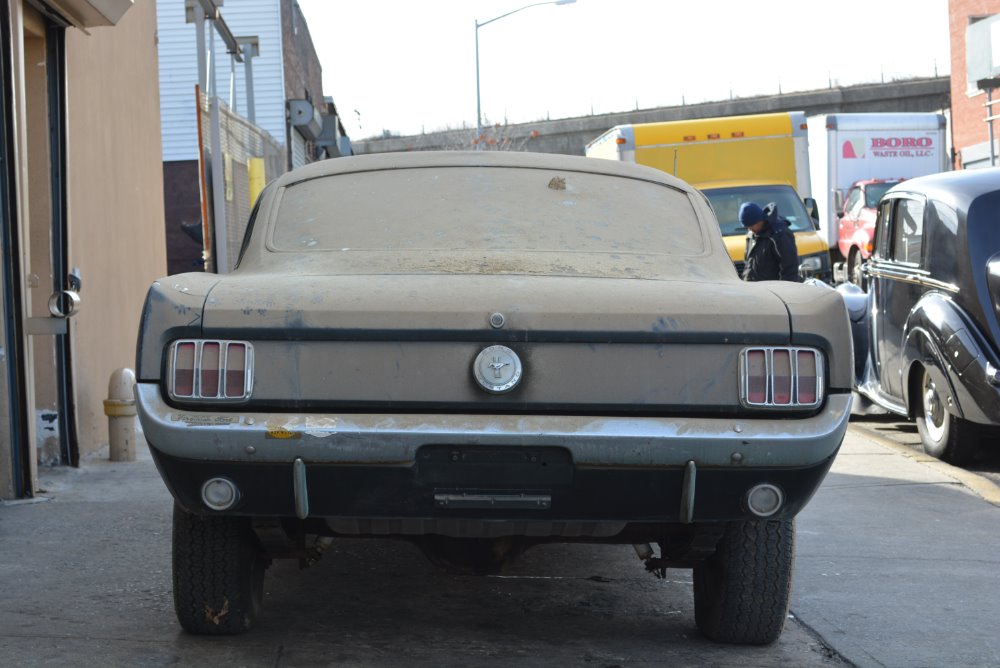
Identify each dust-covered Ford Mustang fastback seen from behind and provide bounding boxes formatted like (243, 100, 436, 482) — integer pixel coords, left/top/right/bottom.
(136, 152, 852, 644)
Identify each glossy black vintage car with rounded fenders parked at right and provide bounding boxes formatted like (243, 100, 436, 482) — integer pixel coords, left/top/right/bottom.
(838, 169, 1000, 464)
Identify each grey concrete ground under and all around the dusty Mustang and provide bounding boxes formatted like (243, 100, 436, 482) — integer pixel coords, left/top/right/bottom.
(0, 429, 1000, 667)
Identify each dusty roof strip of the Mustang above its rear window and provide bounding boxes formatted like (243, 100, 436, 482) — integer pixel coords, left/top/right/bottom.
(275, 151, 693, 192)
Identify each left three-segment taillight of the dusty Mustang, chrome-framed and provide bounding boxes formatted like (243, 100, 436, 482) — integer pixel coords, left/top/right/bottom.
(167, 339, 253, 401)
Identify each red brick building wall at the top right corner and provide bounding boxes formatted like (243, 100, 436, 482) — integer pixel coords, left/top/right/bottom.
(948, 0, 1000, 168)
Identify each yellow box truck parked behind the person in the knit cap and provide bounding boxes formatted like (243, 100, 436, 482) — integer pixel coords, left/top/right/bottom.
(586, 111, 833, 282)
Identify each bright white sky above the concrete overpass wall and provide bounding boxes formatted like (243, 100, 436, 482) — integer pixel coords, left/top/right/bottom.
(298, 0, 950, 139)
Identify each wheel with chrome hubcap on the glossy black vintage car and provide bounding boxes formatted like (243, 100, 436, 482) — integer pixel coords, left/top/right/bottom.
(917, 369, 979, 466)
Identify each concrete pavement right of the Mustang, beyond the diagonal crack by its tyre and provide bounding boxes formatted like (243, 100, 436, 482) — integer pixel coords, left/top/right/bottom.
(792, 429, 1000, 668)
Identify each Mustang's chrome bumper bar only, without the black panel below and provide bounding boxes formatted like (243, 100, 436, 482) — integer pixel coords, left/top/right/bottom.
(135, 383, 851, 468)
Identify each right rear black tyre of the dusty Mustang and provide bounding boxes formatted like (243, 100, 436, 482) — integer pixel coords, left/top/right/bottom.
(694, 520, 795, 645)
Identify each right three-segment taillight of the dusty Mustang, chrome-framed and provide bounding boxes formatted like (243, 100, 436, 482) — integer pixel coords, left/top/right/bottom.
(740, 347, 823, 408)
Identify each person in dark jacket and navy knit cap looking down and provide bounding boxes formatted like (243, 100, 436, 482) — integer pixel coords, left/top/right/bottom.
(740, 202, 801, 282)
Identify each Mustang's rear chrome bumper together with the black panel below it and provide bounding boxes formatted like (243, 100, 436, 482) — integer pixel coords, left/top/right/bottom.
(136, 384, 851, 536)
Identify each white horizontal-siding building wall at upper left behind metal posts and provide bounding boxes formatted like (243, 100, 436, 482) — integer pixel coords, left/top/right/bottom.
(156, 0, 285, 161)
